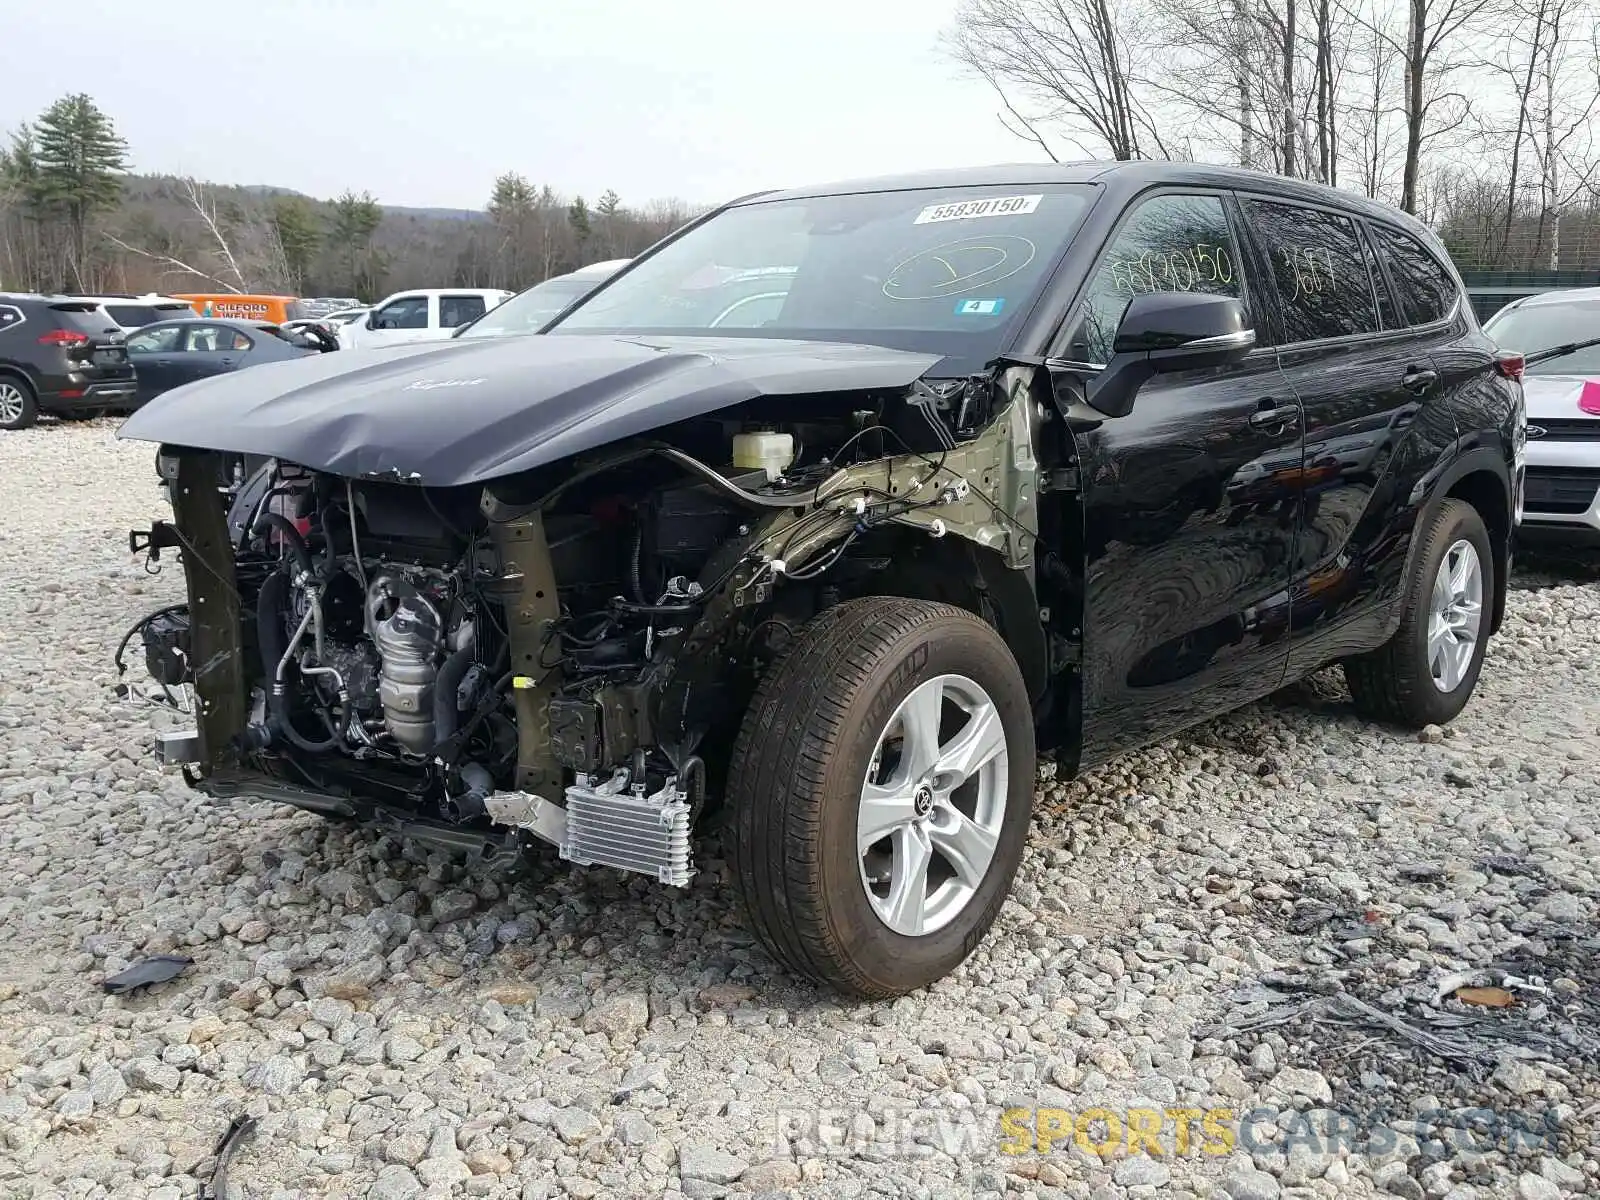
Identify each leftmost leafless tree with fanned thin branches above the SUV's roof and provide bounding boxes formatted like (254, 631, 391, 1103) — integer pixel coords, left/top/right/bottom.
(947, 0, 1170, 160)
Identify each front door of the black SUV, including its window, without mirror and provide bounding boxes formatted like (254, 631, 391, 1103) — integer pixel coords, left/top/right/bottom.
(1058, 192, 1301, 765)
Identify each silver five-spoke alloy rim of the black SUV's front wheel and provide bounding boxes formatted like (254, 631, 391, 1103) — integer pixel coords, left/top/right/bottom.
(856, 675, 1010, 938)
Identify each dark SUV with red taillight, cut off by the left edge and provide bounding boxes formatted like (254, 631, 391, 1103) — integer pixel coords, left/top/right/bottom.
(0, 293, 134, 429)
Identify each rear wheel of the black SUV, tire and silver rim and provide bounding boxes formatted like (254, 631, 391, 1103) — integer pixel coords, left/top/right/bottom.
(1344, 499, 1496, 730)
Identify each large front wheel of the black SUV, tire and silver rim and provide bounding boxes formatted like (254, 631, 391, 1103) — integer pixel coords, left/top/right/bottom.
(728, 597, 1035, 1000)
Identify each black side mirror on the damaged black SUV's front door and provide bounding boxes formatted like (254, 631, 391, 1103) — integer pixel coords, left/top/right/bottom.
(1086, 291, 1256, 416)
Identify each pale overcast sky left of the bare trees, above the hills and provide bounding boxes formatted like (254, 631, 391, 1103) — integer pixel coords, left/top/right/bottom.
(0, 0, 1038, 208)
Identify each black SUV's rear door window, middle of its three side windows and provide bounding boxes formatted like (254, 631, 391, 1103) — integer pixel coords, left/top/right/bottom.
(1245, 200, 1379, 344)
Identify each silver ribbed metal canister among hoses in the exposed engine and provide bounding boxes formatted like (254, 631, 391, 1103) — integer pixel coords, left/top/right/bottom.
(366, 574, 445, 754)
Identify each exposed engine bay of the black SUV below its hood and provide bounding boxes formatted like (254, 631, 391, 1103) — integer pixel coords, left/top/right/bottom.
(130, 379, 1037, 885)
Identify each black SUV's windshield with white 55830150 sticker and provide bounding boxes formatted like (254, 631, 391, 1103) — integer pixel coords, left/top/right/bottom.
(549, 186, 1091, 366)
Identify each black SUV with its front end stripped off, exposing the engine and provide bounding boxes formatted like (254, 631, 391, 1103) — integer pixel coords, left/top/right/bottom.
(122, 163, 1525, 997)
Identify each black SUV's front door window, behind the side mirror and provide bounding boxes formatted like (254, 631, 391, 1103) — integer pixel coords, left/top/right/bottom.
(1062, 195, 1248, 363)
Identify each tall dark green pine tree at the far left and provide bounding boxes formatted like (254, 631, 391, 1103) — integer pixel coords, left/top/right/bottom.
(29, 93, 128, 288)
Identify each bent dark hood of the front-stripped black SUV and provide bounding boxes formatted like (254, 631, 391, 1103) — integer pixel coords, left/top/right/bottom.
(118, 334, 939, 488)
